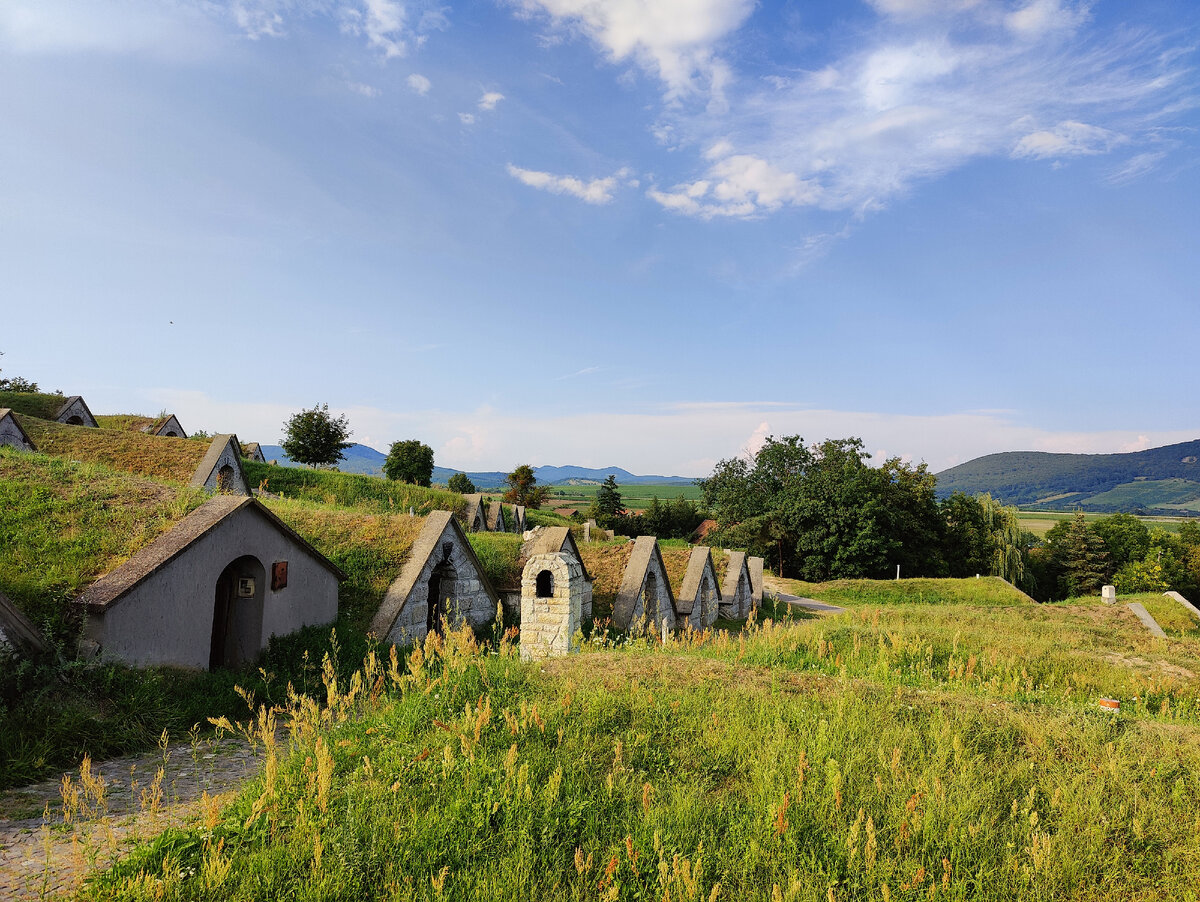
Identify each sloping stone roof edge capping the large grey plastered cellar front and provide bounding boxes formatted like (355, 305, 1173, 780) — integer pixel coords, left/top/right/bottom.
(76, 495, 346, 613)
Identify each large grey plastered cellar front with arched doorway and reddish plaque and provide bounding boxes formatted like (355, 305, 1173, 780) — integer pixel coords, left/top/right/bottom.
(74, 495, 344, 671)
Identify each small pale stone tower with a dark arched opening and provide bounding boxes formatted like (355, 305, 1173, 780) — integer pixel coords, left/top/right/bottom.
(521, 552, 584, 661)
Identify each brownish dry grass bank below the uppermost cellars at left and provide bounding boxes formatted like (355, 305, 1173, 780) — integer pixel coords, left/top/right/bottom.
(19, 416, 209, 482)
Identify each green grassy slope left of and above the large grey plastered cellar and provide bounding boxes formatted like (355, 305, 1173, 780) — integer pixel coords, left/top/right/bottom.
(0, 448, 208, 638)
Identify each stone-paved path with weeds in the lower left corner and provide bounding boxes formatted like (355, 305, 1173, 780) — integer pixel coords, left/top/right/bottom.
(0, 736, 262, 902)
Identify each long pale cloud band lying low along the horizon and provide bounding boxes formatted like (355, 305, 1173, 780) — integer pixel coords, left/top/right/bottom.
(142, 390, 1196, 476)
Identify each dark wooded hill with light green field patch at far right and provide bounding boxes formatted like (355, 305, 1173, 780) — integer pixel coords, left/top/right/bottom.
(937, 439, 1200, 516)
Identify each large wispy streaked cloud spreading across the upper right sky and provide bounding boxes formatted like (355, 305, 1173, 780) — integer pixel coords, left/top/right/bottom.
(580, 0, 1198, 218)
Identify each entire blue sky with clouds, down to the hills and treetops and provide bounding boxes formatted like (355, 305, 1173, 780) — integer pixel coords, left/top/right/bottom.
(0, 0, 1200, 475)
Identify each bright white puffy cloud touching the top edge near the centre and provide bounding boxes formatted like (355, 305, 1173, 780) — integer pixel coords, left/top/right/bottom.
(518, 0, 755, 100)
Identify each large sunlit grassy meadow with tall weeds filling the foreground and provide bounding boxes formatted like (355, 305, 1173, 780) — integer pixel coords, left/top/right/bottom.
(70, 585, 1200, 902)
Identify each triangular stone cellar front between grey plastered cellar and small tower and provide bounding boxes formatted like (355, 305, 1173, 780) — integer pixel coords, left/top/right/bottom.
(371, 511, 499, 644)
